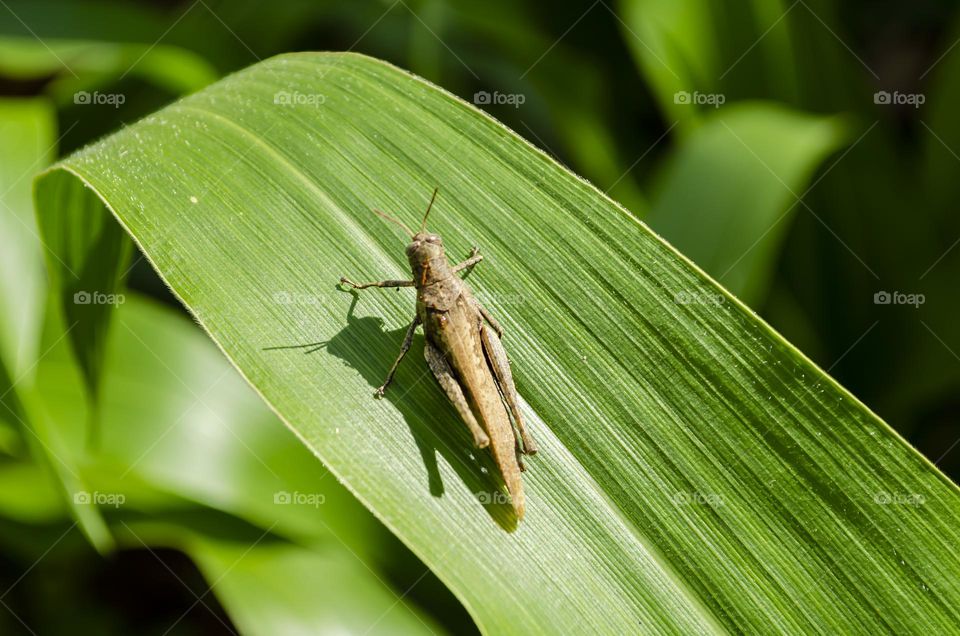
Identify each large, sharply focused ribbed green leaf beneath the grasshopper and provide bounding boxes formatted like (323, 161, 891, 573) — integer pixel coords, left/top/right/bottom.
(36, 54, 960, 633)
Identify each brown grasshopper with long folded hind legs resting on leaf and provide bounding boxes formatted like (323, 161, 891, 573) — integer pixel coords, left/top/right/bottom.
(340, 189, 537, 520)
